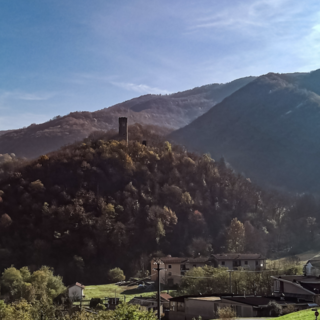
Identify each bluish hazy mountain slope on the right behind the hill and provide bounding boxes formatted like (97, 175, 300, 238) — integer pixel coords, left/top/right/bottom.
(170, 70, 320, 191)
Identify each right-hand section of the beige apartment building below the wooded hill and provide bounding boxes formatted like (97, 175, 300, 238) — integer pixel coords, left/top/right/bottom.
(211, 253, 266, 271)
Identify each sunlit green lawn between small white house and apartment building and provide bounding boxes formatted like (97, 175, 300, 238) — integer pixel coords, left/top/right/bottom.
(84, 284, 174, 302)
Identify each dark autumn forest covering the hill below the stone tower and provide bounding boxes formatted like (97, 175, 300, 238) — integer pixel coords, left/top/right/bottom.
(0, 125, 320, 284)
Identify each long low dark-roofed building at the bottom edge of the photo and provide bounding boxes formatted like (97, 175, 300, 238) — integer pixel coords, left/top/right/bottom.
(169, 294, 316, 320)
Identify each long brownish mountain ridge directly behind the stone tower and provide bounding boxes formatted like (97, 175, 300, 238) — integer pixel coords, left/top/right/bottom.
(0, 77, 254, 158)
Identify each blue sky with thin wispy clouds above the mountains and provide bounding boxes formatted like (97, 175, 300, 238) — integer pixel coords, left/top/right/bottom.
(0, 0, 320, 130)
